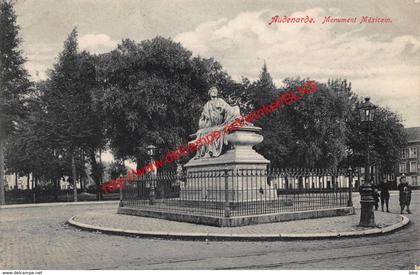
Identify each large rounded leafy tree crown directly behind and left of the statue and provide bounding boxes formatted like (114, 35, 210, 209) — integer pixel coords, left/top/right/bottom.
(100, 37, 237, 166)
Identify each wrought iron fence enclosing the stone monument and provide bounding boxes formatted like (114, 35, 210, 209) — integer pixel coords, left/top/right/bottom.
(121, 169, 351, 217)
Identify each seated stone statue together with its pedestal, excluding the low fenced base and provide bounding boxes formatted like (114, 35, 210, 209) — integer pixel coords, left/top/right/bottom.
(180, 87, 276, 202)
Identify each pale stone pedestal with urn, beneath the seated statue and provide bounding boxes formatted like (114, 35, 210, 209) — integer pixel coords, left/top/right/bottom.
(180, 126, 277, 203)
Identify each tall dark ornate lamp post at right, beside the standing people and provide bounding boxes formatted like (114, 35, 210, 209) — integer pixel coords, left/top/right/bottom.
(359, 97, 376, 227)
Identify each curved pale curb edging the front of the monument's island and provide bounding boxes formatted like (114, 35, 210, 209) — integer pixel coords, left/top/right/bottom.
(67, 215, 410, 241)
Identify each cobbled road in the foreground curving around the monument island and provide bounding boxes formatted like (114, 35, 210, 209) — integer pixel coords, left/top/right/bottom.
(0, 191, 420, 269)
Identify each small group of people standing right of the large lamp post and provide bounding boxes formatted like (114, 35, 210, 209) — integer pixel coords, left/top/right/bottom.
(374, 174, 411, 214)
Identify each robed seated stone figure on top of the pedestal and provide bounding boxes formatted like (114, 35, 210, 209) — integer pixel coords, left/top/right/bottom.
(195, 87, 241, 159)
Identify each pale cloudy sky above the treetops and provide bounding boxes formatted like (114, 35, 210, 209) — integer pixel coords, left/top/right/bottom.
(16, 0, 420, 131)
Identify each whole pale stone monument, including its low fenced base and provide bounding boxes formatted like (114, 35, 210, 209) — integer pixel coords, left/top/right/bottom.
(118, 85, 354, 227)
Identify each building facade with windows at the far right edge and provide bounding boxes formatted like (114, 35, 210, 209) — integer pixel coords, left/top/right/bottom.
(397, 127, 420, 186)
